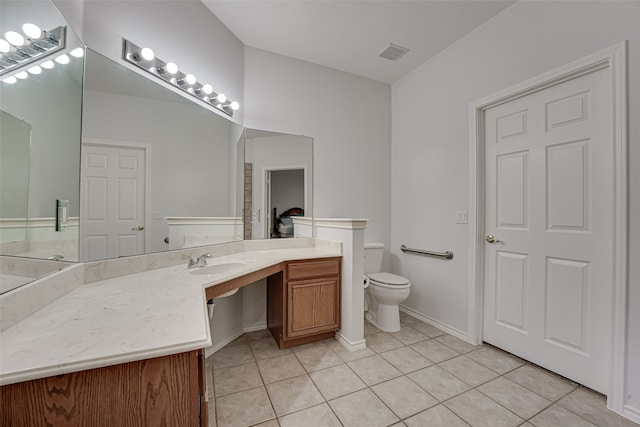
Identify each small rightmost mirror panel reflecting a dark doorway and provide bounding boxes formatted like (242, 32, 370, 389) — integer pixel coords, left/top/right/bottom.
(244, 129, 313, 239)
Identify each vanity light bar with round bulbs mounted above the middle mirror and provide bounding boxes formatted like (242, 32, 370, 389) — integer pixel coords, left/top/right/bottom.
(122, 39, 240, 117)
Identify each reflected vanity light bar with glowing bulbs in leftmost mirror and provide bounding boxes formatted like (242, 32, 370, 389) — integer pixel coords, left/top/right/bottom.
(0, 24, 66, 76)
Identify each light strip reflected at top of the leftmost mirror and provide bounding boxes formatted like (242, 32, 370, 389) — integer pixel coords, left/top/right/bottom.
(0, 26, 66, 76)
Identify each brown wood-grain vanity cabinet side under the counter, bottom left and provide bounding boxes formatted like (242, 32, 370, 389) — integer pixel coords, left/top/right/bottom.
(0, 350, 208, 427)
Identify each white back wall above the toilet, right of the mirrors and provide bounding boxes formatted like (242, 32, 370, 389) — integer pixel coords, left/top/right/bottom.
(244, 47, 391, 260)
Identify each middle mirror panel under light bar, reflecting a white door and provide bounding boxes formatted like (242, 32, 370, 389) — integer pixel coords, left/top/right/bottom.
(80, 49, 244, 261)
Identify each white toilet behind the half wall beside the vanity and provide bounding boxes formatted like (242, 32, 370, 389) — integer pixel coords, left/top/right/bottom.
(364, 243, 411, 332)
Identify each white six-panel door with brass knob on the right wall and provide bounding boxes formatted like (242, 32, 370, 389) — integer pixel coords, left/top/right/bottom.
(483, 69, 615, 394)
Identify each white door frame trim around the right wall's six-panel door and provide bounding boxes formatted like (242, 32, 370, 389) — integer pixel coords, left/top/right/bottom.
(468, 41, 629, 414)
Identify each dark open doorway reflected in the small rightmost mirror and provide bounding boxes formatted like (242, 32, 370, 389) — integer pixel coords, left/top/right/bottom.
(265, 168, 305, 239)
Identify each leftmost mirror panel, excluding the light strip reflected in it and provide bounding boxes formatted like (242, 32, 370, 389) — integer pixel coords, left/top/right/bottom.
(0, 0, 83, 291)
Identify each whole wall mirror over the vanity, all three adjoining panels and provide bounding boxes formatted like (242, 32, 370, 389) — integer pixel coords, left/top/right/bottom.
(0, 0, 313, 292)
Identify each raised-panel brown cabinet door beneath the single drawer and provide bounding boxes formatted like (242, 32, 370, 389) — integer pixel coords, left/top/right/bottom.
(287, 277, 340, 337)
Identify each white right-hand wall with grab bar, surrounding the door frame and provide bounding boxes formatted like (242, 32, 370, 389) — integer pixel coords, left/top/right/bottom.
(391, 1, 640, 414)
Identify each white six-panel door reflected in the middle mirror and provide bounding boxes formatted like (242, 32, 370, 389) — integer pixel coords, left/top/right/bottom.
(80, 144, 146, 261)
